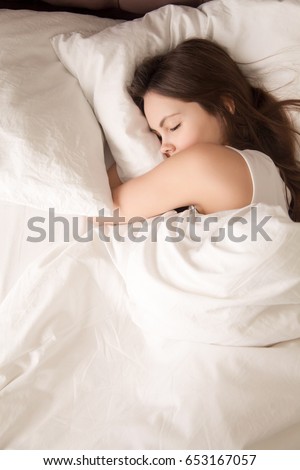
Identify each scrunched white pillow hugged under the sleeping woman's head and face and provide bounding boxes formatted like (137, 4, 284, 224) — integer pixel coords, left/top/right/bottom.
(52, 5, 211, 181)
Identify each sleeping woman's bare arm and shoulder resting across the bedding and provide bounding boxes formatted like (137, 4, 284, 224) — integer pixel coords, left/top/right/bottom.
(112, 144, 252, 221)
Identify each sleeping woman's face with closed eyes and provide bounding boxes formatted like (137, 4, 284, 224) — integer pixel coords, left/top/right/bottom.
(144, 91, 224, 157)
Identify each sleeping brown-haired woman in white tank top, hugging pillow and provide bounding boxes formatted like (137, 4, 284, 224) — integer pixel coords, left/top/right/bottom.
(108, 39, 300, 222)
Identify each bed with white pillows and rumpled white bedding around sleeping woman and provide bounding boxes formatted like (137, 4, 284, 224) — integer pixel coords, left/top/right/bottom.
(0, 0, 300, 450)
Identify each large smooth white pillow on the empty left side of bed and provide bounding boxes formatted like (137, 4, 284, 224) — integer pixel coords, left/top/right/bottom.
(0, 10, 121, 215)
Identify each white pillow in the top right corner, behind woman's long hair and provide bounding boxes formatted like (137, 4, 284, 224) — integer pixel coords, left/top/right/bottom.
(201, 0, 300, 136)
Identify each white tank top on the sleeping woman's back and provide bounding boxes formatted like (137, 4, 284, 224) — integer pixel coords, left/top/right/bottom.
(228, 146, 291, 213)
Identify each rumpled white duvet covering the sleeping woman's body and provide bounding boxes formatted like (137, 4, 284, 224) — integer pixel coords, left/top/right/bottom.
(0, 205, 300, 449)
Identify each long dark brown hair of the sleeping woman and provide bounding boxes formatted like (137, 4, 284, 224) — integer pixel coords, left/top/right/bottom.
(128, 39, 300, 222)
